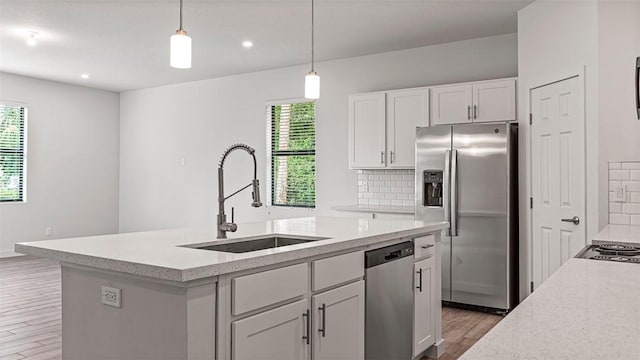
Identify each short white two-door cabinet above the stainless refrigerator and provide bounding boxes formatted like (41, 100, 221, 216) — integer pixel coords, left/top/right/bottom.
(431, 79, 516, 125)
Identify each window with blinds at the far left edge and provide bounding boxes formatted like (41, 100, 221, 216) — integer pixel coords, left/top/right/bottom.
(0, 104, 26, 202)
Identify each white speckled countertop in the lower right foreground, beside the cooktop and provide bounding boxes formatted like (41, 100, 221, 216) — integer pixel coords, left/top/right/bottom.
(460, 259, 640, 360)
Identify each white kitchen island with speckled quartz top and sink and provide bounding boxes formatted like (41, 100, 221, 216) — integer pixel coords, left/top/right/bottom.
(16, 217, 447, 360)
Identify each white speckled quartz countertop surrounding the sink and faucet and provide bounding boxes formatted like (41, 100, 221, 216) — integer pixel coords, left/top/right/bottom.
(15, 217, 447, 282)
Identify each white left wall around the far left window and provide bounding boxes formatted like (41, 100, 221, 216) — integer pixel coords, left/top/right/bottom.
(0, 73, 119, 256)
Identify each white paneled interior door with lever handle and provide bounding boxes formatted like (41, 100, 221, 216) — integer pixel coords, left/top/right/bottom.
(531, 77, 586, 288)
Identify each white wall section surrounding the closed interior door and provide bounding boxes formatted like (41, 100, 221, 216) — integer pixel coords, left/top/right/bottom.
(518, 0, 606, 297)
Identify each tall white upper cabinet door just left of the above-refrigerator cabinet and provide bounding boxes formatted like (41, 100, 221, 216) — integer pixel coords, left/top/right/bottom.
(387, 89, 429, 169)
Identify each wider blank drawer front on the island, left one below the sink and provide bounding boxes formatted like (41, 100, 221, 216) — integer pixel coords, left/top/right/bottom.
(232, 263, 309, 315)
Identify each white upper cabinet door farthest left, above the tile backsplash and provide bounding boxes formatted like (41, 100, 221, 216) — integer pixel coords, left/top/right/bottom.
(349, 93, 386, 169)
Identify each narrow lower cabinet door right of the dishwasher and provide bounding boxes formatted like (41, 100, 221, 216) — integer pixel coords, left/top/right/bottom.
(413, 257, 437, 356)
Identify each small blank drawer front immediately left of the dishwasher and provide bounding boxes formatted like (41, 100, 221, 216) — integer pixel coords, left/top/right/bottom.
(312, 251, 364, 291)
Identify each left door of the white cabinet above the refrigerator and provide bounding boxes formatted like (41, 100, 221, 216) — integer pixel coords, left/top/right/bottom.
(431, 85, 473, 126)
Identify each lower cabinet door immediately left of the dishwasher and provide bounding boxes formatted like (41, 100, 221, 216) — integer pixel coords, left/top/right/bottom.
(311, 280, 365, 360)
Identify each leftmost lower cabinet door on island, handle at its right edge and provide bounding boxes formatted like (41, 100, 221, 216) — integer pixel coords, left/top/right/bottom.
(231, 299, 310, 360)
